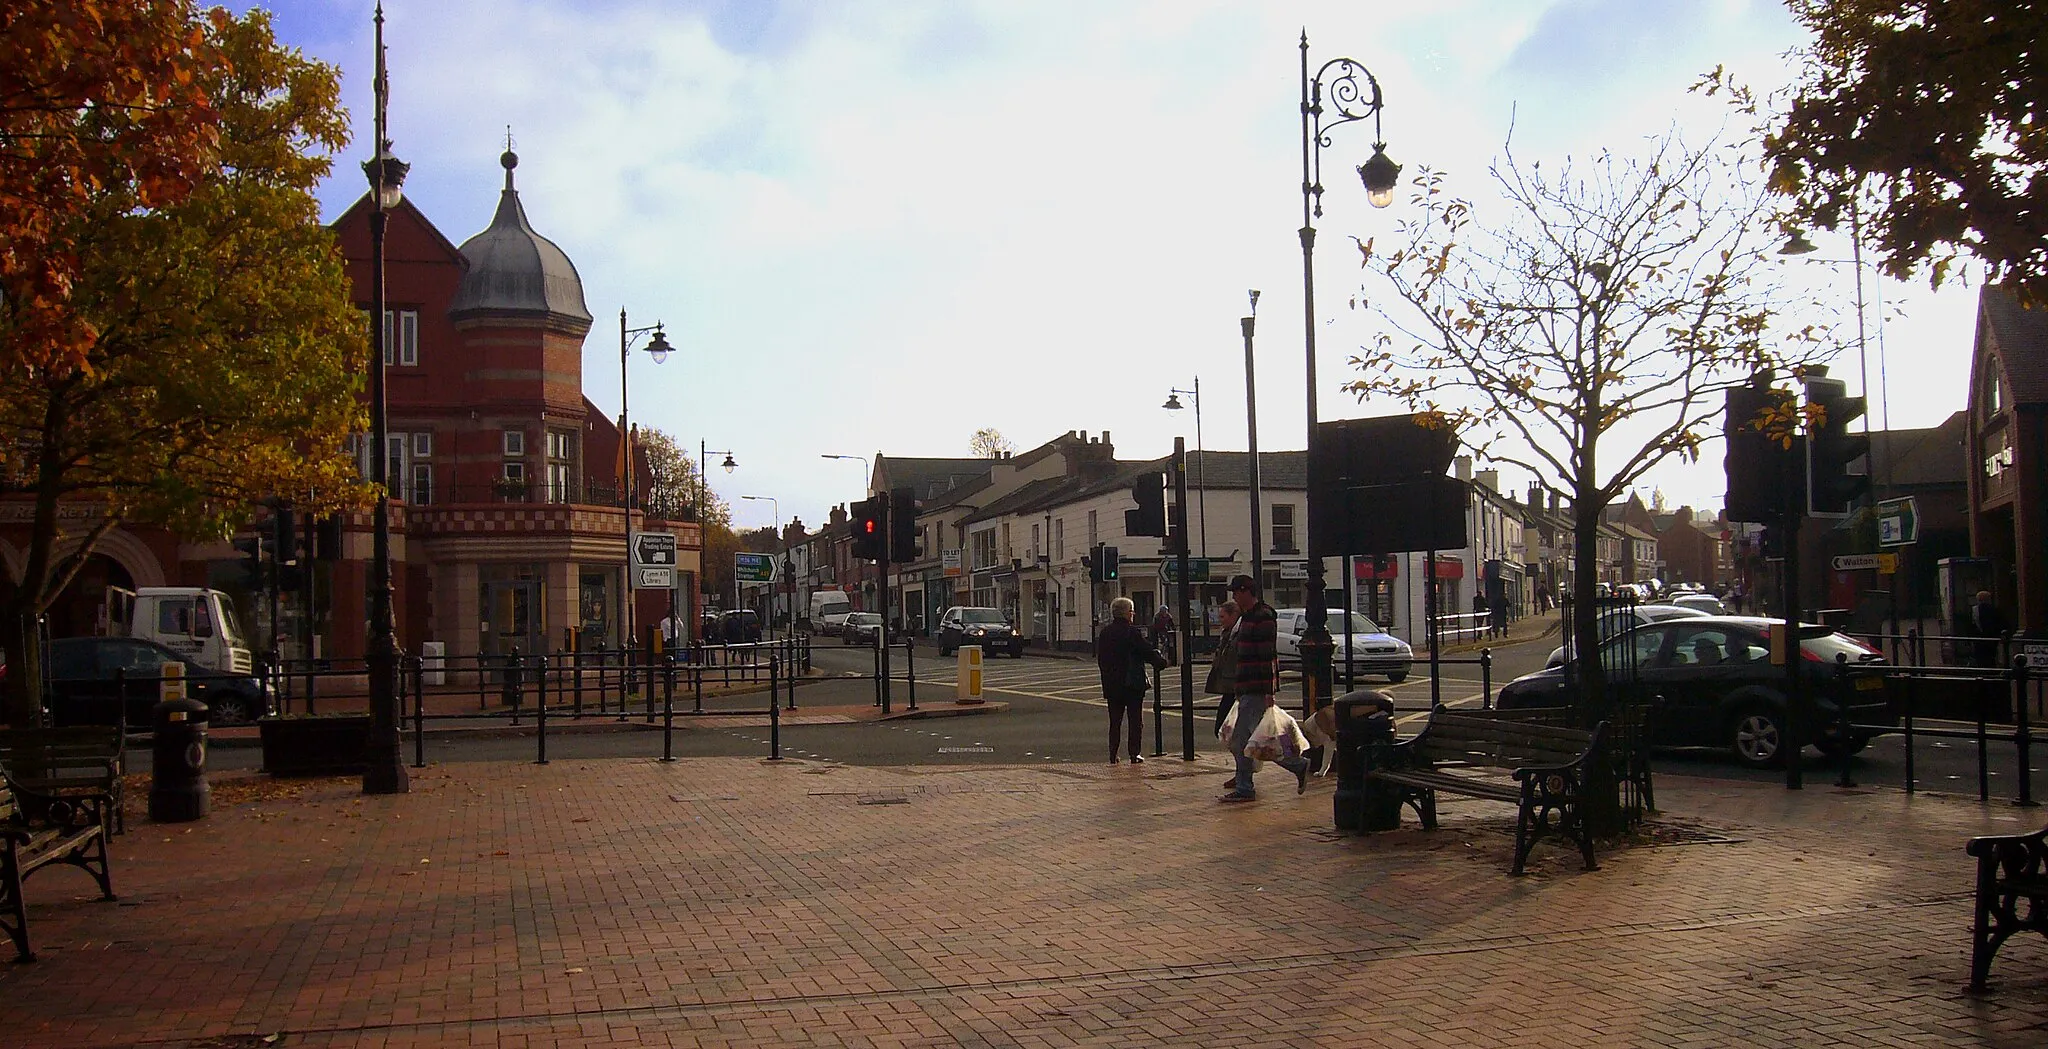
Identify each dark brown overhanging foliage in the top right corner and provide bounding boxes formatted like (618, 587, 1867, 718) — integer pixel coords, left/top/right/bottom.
(1763, 0, 2048, 305)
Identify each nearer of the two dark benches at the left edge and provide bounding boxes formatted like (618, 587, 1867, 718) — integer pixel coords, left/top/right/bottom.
(0, 768, 115, 961)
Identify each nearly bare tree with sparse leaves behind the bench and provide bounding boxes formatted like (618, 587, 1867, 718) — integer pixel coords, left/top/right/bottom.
(1348, 131, 1825, 717)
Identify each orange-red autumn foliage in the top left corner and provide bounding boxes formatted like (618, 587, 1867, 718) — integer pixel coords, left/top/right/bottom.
(0, 0, 225, 369)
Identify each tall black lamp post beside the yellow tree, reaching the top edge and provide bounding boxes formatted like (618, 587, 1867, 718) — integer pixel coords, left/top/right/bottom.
(362, 2, 412, 795)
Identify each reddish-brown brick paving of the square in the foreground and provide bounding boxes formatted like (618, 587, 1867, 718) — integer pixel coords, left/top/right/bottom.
(0, 756, 2048, 1049)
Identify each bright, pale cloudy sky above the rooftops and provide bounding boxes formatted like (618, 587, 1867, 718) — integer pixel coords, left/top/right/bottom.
(247, 0, 1976, 527)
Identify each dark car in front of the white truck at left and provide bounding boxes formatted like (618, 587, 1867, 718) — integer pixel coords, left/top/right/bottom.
(43, 637, 270, 729)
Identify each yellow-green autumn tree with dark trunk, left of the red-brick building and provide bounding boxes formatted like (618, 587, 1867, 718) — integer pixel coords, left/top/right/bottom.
(0, 10, 369, 723)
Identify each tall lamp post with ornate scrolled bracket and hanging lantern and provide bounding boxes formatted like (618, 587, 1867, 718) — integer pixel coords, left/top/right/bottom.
(1302, 31, 1400, 713)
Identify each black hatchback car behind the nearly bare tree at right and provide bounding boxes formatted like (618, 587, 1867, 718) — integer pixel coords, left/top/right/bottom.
(1497, 615, 1896, 768)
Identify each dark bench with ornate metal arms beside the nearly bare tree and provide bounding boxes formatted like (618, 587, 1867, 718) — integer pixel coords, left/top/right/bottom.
(1366, 707, 1608, 875)
